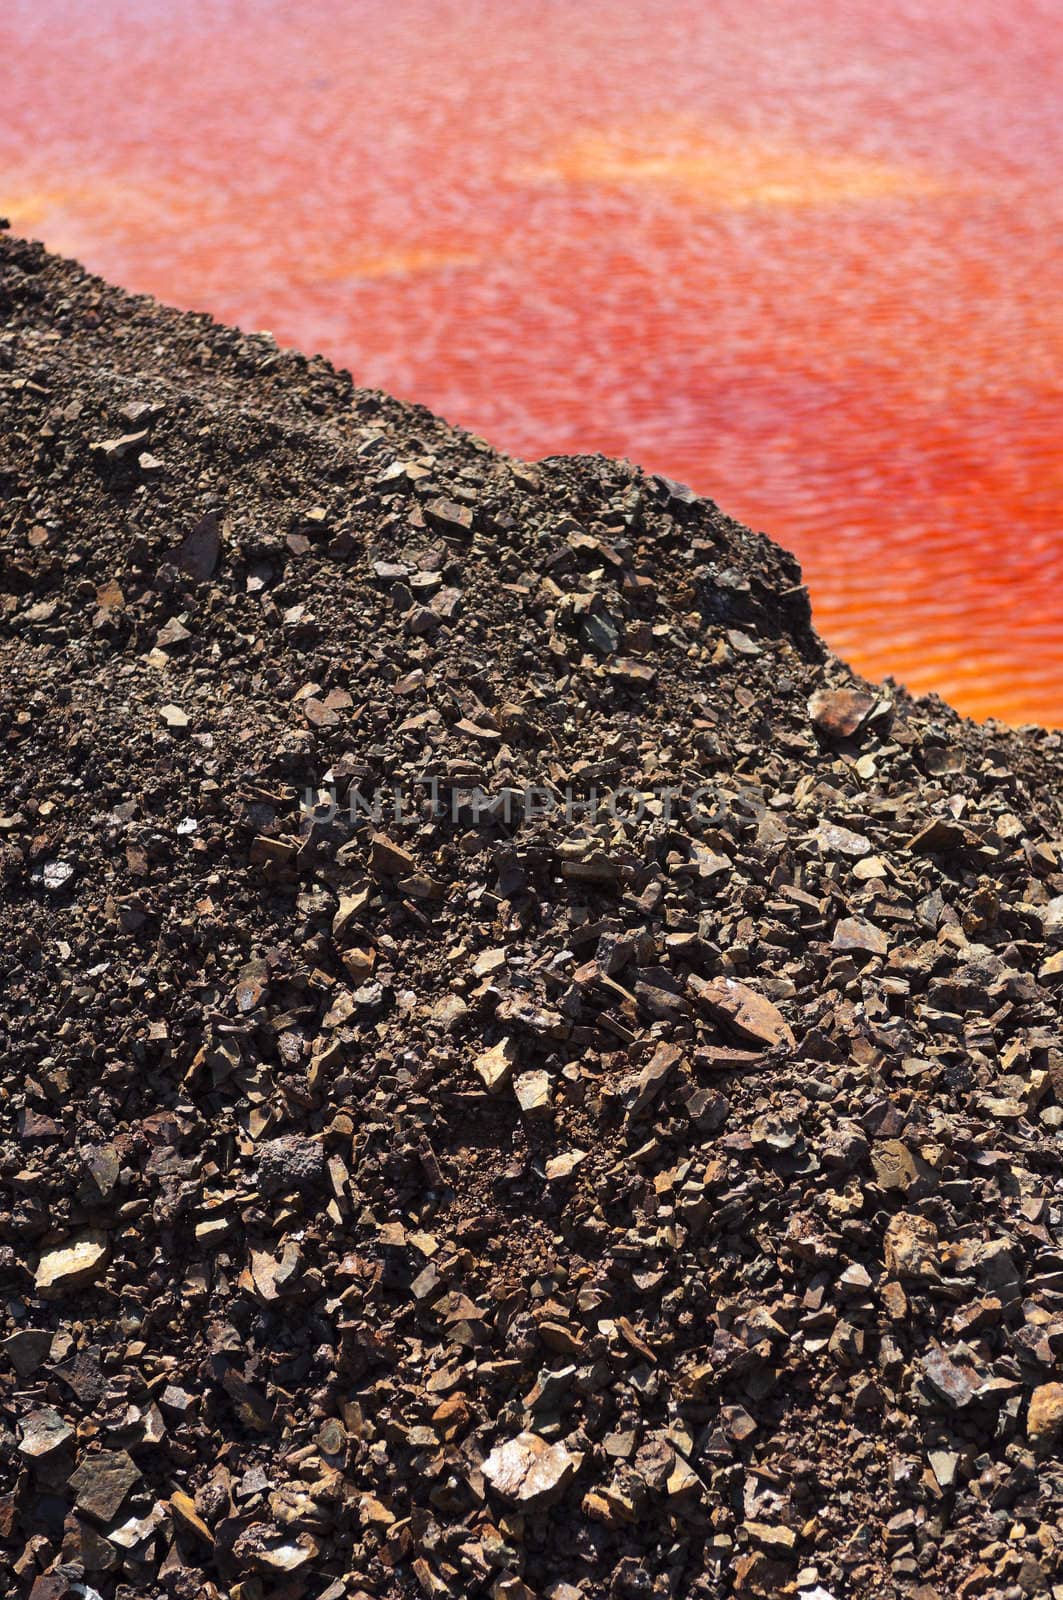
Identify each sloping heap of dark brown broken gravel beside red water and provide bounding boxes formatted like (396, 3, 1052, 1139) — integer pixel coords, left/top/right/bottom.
(0, 237, 1063, 1600)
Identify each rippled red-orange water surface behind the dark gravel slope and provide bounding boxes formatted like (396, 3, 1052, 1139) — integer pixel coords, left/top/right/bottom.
(0, 0, 1063, 725)
